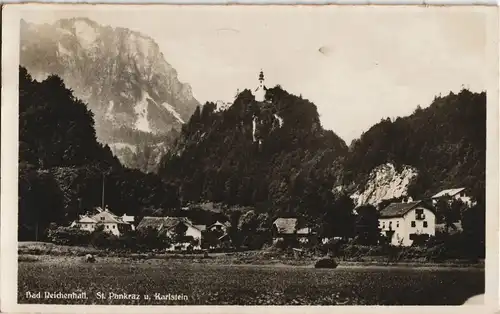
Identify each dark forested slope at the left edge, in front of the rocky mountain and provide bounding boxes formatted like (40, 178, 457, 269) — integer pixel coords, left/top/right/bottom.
(19, 68, 178, 240)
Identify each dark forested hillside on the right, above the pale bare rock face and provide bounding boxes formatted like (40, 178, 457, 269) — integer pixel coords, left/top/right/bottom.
(343, 90, 486, 199)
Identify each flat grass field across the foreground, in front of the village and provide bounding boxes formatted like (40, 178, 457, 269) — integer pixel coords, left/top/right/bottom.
(18, 257, 484, 305)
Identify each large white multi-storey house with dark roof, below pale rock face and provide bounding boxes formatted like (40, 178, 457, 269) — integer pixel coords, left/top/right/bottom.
(379, 201, 436, 246)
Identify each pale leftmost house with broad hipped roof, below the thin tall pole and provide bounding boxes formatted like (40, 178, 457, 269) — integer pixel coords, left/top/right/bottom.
(71, 207, 133, 236)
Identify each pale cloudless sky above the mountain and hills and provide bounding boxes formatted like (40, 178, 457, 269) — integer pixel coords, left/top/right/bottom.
(18, 6, 491, 144)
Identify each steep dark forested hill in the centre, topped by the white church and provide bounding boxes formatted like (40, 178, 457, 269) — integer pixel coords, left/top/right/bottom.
(159, 86, 347, 223)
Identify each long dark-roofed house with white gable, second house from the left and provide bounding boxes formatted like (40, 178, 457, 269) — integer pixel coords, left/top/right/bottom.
(137, 217, 206, 251)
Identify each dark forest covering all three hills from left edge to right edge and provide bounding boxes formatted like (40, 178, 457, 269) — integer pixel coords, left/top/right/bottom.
(19, 68, 486, 253)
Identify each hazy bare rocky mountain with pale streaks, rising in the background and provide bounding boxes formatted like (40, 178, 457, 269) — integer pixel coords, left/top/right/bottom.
(20, 18, 199, 172)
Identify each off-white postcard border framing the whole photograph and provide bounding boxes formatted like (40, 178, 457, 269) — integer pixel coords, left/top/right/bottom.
(0, 4, 500, 314)
